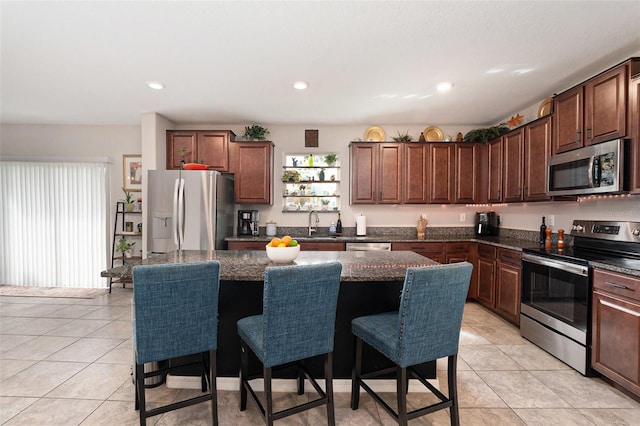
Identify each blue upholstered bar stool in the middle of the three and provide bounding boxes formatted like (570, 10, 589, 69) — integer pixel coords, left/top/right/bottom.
(238, 262, 342, 425)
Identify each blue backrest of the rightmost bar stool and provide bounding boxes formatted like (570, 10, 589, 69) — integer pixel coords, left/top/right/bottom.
(396, 262, 473, 367)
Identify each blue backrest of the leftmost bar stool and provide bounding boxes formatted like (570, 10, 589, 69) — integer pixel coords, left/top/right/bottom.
(133, 260, 220, 364)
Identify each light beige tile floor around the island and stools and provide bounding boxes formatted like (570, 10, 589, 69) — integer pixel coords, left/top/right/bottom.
(0, 288, 640, 426)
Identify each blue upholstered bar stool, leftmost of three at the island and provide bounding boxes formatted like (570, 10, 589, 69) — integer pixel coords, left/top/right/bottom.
(133, 260, 220, 425)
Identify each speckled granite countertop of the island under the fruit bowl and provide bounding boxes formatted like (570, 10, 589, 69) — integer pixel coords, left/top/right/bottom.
(101, 250, 438, 282)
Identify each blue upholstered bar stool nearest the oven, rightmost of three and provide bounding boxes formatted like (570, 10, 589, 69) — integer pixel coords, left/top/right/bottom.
(351, 262, 473, 425)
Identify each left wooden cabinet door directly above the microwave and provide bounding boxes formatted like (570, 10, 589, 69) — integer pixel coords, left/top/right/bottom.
(553, 86, 584, 154)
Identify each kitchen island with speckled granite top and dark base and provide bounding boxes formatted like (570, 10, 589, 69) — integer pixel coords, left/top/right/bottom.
(102, 250, 438, 378)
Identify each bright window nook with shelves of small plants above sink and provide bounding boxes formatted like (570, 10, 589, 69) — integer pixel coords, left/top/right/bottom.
(281, 153, 340, 213)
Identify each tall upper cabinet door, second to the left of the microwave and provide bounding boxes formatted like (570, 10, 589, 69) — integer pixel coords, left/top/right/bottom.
(502, 127, 525, 202)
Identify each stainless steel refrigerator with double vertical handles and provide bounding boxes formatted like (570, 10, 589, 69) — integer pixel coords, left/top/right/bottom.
(146, 170, 235, 253)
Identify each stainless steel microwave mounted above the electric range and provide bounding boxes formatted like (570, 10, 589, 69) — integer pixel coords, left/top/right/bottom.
(547, 139, 629, 196)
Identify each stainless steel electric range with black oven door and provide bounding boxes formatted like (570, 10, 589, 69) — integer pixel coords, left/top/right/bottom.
(520, 220, 640, 375)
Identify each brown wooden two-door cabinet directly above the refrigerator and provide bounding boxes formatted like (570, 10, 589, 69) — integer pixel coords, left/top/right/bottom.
(167, 130, 236, 172)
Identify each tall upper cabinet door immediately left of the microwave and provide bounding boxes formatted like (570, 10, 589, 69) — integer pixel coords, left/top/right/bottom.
(523, 116, 552, 201)
